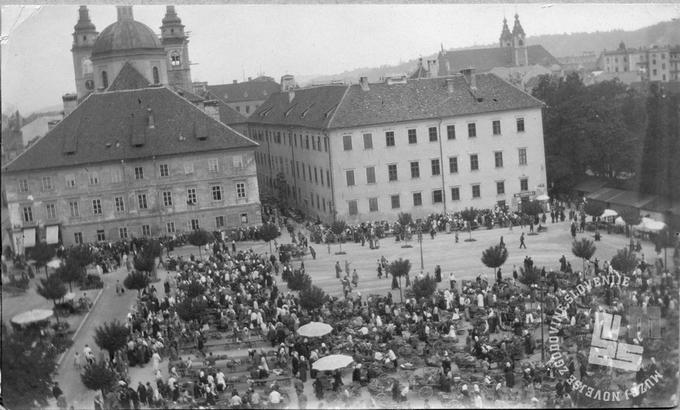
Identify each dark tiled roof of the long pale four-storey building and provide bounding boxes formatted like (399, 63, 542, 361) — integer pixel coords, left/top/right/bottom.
(249, 74, 542, 128)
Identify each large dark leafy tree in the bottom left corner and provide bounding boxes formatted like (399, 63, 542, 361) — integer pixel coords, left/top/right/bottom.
(0, 322, 58, 409)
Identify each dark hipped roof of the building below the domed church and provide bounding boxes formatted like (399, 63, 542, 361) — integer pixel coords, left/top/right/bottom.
(3, 87, 257, 172)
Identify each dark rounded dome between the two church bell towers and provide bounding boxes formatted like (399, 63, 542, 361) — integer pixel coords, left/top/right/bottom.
(92, 19, 162, 57)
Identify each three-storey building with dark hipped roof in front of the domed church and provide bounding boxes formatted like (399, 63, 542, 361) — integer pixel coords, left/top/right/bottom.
(2, 87, 260, 252)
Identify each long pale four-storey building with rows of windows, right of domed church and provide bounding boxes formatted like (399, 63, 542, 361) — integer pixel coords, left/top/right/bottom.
(249, 70, 546, 222)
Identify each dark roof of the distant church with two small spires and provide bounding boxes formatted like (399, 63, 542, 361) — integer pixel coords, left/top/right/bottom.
(439, 45, 559, 74)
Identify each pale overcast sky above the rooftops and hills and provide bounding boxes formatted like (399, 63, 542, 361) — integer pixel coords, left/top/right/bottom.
(2, 3, 680, 115)
